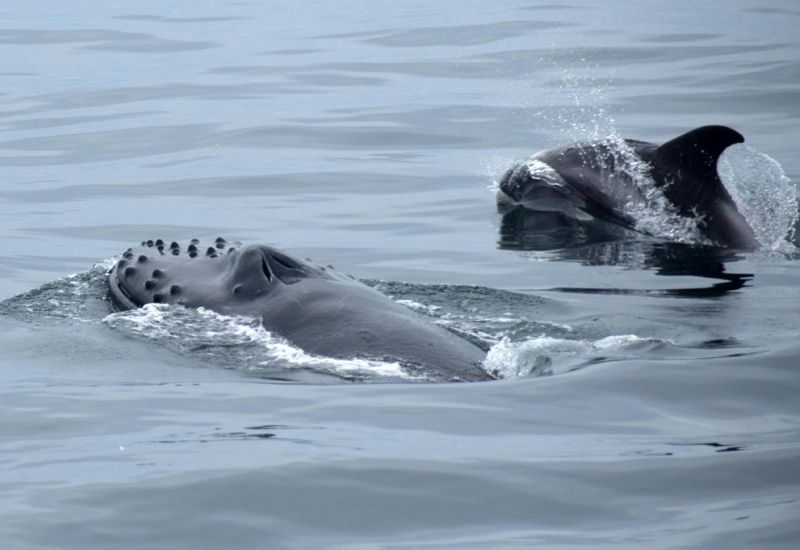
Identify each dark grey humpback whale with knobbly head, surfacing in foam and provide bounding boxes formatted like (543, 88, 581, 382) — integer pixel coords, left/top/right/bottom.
(108, 238, 491, 381)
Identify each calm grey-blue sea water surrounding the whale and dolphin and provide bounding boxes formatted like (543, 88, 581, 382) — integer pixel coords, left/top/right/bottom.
(0, 0, 800, 549)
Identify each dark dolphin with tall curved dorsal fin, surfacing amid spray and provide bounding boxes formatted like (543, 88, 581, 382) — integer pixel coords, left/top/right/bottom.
(497, 126, 758, 250)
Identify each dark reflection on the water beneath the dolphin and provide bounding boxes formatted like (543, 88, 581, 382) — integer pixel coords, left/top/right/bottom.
(497, 208, 753, 297)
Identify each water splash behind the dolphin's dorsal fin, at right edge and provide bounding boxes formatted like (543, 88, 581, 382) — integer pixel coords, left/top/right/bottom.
(717, 144, 798, 252)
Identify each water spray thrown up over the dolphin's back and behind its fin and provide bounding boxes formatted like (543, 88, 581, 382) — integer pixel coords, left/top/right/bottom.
(504, 66, 798, 252)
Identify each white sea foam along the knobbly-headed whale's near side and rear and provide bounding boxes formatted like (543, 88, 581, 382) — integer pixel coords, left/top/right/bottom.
(103, 301, 664, 381)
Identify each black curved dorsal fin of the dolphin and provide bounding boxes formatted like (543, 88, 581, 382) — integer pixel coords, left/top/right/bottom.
(656, 126, 744, 179)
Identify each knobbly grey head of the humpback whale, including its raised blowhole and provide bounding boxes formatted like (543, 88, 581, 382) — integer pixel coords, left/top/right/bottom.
(109, 238, 334, 312)
